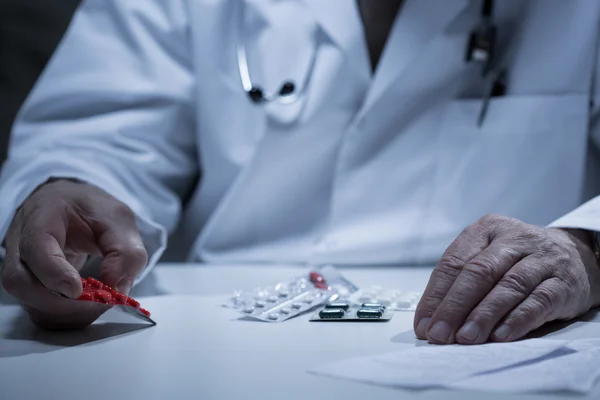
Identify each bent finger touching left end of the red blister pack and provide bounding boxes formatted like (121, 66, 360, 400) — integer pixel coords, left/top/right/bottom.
(18, 208, 82, 298)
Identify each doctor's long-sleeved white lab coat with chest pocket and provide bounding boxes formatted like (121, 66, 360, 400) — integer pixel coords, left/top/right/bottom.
(0, 0, 600, 282)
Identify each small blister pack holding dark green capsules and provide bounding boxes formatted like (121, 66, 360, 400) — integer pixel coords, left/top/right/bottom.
(310, 301, 393, 322)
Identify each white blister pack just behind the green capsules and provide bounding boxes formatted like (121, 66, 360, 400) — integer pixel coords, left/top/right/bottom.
(343, 286, 421, 311)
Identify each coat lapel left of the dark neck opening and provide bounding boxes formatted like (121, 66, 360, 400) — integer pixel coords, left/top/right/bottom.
(302, 0, 371, 80)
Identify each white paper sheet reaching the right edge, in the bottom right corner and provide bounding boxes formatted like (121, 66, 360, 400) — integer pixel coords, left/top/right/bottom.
(448, 347, 600, 393)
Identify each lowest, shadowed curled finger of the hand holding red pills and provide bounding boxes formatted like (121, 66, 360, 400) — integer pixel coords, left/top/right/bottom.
(2, 241, 109, 329)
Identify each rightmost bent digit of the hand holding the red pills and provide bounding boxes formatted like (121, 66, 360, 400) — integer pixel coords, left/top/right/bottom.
(84, 203, 148, 294)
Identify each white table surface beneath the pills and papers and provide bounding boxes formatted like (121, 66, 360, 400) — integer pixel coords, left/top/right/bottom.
(0, 265, 600, 400)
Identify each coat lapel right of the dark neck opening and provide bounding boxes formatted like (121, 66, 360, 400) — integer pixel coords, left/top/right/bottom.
(358, 0, 473, 115)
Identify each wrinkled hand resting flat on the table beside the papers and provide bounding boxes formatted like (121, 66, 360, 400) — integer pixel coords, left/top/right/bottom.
(414, 216, 600, 344)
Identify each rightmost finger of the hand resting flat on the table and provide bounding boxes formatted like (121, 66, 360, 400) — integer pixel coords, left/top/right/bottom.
(491, 278, 569, 342)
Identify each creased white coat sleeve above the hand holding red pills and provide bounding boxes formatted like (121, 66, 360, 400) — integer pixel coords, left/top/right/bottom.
(0, 0, 198, 279)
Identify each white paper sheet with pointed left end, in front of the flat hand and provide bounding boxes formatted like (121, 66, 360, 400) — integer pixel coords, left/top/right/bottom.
(309, 339, 567, 388)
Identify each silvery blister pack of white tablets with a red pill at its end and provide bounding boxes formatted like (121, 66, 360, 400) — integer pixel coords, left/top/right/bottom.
(224, 266, 358, 322)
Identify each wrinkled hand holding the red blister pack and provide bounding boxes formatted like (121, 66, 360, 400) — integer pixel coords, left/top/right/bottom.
(2, 180, 147, 329)
